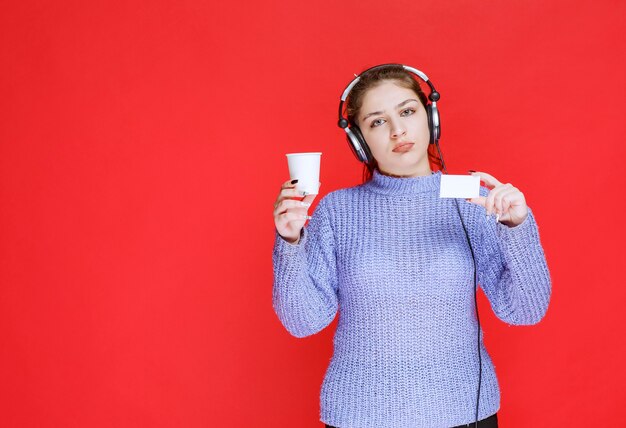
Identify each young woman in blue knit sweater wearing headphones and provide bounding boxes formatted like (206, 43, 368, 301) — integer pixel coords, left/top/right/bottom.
(273, 65, 551, 428)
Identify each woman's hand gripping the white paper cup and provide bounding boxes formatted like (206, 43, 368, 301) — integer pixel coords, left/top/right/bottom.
(274, 180, 317, 244)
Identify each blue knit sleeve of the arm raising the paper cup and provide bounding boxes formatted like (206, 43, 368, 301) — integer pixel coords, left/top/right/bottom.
(272, 199, 338, 337)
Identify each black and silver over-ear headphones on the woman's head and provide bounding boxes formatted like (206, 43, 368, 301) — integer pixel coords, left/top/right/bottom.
(338, 64, 441, 164)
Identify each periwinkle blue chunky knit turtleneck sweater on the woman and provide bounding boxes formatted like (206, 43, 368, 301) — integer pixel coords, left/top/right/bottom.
(272, 172, 551, 428)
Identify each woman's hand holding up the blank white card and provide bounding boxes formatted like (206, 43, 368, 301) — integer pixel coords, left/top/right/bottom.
(467, 171, 528, 227)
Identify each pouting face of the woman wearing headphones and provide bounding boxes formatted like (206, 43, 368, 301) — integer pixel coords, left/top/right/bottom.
(357, 81, 431, 177)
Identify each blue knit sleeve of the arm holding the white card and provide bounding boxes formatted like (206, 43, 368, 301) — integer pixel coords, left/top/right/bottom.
(475, 189, 551, 325)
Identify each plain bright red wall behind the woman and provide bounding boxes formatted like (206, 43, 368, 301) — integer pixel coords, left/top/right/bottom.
(0, 0, 626, 427)
